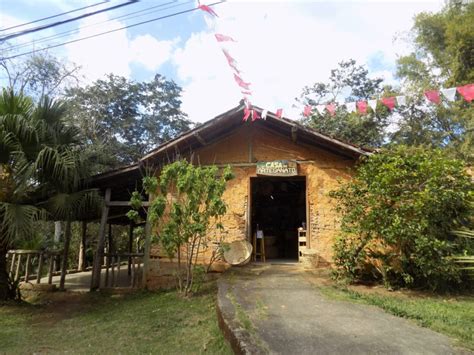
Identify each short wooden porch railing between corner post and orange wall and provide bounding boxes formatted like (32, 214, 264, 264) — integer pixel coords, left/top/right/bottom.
(104, 253, 144, 288)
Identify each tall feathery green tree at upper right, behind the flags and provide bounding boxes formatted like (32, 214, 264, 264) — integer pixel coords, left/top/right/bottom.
(392, 1, 474, 161)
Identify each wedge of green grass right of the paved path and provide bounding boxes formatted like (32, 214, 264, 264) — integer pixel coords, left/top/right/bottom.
(318, 286, 474, 350)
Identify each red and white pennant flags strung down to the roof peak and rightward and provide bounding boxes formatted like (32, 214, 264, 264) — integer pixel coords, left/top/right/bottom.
(198, 0, 474, 122)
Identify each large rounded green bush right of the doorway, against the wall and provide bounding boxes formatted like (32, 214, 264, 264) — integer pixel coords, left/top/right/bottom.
(331, 146, 474, 289)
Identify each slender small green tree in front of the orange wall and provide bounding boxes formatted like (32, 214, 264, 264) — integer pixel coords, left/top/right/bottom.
(128, 160, 233, 295)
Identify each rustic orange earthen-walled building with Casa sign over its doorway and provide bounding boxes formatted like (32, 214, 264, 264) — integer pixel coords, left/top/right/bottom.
(88, 104, 369, 285)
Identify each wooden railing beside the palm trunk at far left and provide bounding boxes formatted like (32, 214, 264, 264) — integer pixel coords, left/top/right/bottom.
(7, 249, 62, 284)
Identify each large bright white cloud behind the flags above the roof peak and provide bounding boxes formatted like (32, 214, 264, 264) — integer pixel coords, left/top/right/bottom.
(174, 1, 441, 121)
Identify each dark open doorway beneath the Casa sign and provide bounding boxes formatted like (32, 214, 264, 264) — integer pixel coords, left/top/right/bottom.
(250, 176, 306, 260)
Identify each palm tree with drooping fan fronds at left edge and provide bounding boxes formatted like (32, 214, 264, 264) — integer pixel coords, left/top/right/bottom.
(0, 89, 90, 300)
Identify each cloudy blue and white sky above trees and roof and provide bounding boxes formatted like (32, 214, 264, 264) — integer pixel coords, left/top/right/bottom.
(0, 0, 443, 122)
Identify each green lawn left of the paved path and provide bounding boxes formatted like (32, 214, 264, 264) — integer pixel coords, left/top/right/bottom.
(0, 288, 231, 354)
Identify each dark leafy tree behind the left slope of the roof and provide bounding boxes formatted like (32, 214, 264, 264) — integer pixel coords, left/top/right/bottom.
(66, 74, 190, 170)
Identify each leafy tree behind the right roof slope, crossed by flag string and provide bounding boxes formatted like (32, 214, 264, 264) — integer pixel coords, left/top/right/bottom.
(298, 59, 389, 147)
